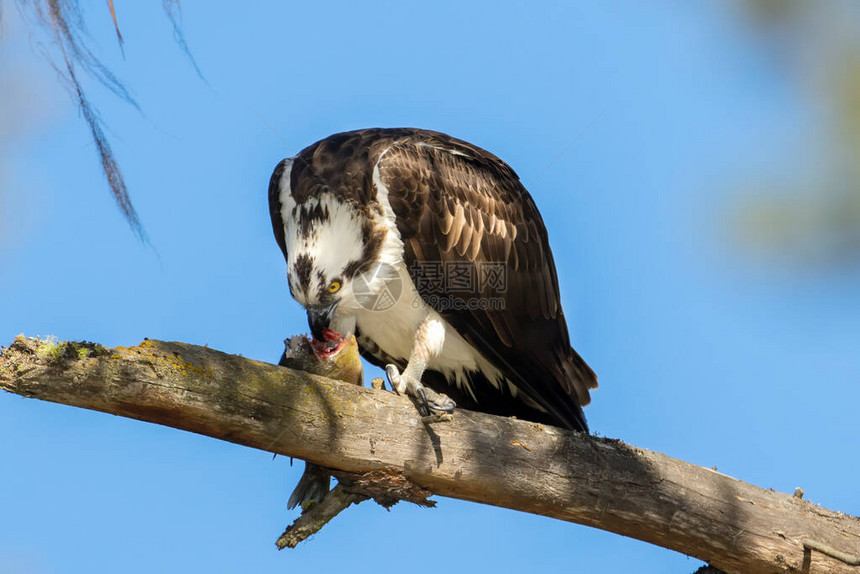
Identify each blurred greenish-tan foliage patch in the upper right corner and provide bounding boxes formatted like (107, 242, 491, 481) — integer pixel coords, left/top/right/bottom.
(734, 0, 860, 267)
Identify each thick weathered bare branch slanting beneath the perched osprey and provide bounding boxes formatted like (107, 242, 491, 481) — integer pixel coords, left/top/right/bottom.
(0, 338, 860, 573)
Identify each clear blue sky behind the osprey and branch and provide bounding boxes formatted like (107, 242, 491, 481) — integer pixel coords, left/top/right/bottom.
(0, 0, 860, 573)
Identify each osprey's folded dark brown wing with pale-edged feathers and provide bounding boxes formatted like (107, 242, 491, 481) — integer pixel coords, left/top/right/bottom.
(379, 131, 597, 430)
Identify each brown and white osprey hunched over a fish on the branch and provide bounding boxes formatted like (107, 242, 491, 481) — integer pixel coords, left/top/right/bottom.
(269, 128, 597, 431)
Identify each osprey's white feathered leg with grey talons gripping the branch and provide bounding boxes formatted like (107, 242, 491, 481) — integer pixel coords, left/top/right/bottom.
(385, 317, 457, 416)
